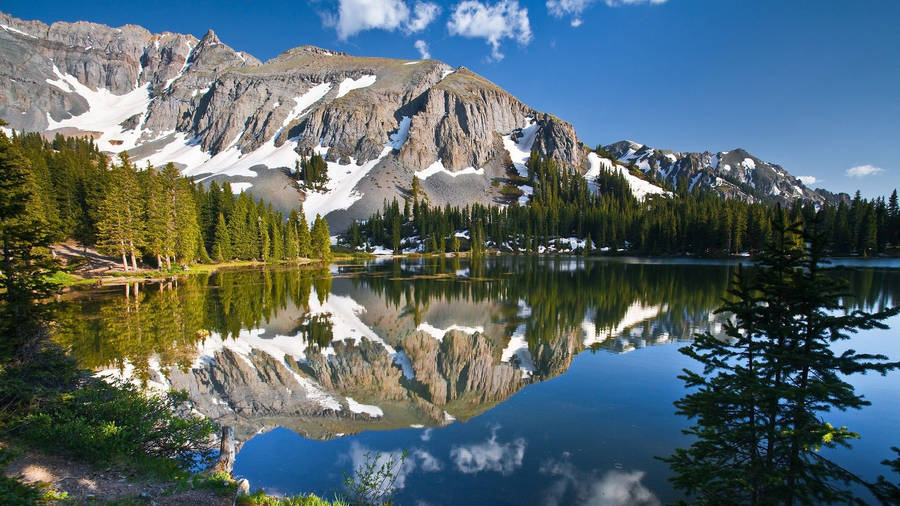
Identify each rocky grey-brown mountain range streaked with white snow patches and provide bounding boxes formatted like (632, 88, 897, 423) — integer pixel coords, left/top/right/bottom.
(0, 13, 836, 230)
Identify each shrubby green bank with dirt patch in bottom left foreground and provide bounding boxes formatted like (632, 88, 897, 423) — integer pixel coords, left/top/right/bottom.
(0, 344, 342, 506)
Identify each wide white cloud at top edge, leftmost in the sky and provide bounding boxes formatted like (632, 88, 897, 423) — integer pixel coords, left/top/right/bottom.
(323, 0, 441, 40)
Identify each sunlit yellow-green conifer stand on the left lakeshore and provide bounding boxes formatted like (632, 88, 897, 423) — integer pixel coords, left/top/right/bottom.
(8, 134, 331, 270)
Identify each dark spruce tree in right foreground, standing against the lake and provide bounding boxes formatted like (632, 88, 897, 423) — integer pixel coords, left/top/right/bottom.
(664, 220, 900, 504)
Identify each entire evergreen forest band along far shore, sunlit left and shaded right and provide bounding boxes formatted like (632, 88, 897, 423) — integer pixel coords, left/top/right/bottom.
(10, 127, 900, 260)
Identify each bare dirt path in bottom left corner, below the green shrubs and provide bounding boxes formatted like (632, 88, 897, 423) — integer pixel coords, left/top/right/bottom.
(3, 451, 234, 506)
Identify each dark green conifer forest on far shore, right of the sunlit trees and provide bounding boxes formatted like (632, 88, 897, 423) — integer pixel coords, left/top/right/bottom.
(344, 148, 900, 256)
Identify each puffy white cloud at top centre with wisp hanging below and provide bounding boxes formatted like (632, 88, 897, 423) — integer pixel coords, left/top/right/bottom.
(447, 0, 531, 61)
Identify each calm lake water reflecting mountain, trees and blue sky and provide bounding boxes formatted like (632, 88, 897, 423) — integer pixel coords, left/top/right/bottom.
(58, 257, 900, 504)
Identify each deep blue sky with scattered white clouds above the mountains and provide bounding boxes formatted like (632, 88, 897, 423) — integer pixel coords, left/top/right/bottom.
(7, 0, 900, 196)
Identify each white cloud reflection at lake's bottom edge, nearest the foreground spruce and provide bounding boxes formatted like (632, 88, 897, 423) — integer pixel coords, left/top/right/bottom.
(540, 454, 660, 506)
